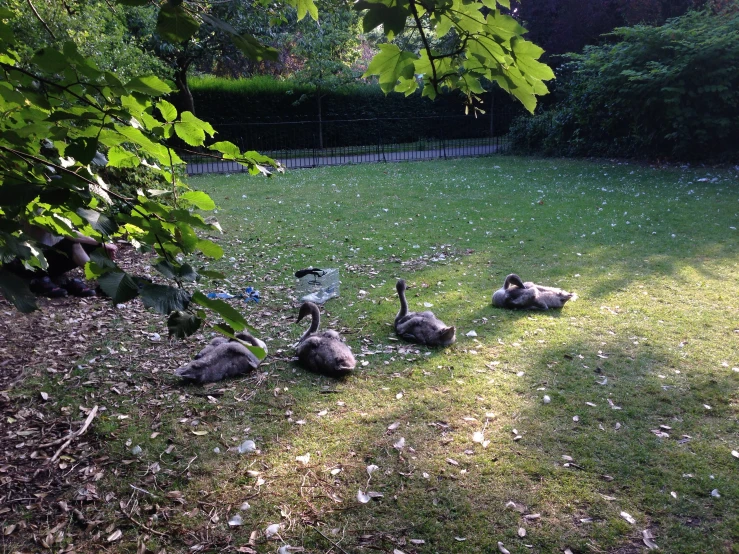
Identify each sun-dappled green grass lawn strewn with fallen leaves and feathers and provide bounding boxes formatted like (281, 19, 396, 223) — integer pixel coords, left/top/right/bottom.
(5, 157, 739, 554)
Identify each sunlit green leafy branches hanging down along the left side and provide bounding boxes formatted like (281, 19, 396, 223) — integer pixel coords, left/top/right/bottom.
(0, 10, 279, 340)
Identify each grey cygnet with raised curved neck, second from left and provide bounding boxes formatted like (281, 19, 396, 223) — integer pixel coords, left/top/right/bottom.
(295, 302, 357, 376)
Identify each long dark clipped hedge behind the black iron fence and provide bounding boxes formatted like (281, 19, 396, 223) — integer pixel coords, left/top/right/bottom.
(191, 77, 513, 150)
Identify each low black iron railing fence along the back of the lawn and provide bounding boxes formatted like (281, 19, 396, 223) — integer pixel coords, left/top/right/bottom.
(182, 114, 510, 175)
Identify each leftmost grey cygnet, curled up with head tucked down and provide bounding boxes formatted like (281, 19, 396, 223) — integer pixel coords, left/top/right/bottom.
(175, 332, 267, 384)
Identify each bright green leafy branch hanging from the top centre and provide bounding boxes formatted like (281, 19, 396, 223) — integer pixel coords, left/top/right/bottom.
(354, 0, 554, 113)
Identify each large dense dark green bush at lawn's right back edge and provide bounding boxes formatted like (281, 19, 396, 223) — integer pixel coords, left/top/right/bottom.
(512, 11, 739, 160)
